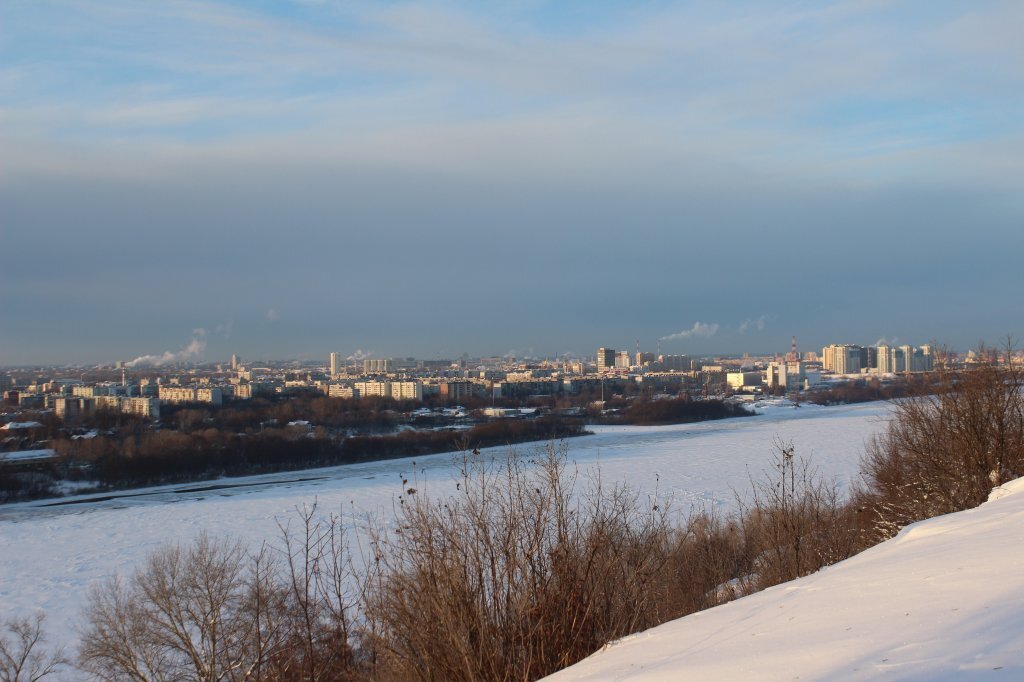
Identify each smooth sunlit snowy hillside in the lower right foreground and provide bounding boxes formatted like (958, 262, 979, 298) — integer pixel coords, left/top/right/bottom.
(547, 479, 1024, 682)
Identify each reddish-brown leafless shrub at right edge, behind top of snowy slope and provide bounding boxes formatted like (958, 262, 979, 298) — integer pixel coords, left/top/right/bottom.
(864, 343, 1024, 539)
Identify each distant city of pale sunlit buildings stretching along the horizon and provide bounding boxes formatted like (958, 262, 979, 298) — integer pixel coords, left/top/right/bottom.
(0, 339, 998, 418)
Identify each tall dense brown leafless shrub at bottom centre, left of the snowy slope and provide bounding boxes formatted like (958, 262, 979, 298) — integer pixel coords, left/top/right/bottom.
(368, 446, 671, 680)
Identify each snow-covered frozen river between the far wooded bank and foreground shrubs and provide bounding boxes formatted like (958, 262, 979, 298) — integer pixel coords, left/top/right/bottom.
(0, 402, 889, 646)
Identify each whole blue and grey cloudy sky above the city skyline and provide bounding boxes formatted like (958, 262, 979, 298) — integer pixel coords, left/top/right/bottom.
(0, 0, 1024, 365)
